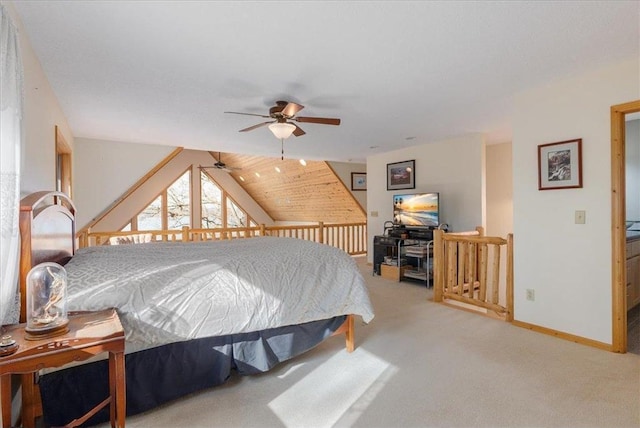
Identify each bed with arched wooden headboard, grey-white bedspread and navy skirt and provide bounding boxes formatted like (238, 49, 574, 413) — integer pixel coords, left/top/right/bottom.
(20, 192, 374, 426)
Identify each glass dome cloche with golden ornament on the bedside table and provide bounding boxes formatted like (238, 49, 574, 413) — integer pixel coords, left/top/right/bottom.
(25, 262, 69, 339)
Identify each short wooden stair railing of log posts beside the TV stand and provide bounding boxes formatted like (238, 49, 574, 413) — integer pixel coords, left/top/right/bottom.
(433, 228, 513, 321)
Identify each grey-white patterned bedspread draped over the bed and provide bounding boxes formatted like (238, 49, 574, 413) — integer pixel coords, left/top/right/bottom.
(65, 237, 373, 347)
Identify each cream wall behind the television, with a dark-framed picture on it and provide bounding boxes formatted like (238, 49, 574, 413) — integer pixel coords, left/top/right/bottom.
(367, 134, 485, 262)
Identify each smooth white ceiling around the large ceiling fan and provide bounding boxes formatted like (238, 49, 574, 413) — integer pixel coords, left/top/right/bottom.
(14, 0, 640, 162)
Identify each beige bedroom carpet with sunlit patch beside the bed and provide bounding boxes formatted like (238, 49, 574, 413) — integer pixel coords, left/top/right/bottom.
(96, 259, 640, 428)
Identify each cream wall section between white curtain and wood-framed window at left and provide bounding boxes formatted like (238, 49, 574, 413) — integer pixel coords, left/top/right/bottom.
(0, 1, 74, 196)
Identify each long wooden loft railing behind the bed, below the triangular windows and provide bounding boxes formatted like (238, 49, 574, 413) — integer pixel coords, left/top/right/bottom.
(78, 222, 367, 255)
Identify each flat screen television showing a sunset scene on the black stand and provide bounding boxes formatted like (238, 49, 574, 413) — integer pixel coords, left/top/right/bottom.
(393, 193, 440, 229)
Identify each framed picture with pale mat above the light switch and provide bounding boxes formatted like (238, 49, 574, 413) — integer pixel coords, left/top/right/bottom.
(538, 138, 582, 190)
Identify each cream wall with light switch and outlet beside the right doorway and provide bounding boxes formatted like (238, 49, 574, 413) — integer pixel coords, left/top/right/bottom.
(513, 58, 640, 344)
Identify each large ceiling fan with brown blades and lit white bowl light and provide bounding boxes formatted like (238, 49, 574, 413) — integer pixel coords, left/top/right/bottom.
(225, 101, 340, 139)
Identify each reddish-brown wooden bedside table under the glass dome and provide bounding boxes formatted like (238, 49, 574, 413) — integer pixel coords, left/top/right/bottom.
(0, 309, 126, 428)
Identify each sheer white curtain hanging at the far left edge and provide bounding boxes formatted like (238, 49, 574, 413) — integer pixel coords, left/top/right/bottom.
(0, 4, 23, 324)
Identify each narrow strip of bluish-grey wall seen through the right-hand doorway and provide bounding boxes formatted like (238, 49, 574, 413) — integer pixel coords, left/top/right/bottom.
(625, 119, 640, 220)
